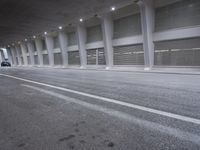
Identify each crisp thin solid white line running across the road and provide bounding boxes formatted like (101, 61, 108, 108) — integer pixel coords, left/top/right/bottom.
(0, 74, 200, 124)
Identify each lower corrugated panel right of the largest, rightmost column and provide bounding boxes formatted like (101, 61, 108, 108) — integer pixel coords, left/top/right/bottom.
(154, 38, 200, 66)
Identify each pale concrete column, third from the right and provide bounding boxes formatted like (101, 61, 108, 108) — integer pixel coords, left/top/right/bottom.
(77, 24, 87, 68)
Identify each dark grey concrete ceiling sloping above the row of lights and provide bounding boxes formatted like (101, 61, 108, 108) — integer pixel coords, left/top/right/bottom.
(0, 0, 180, 45)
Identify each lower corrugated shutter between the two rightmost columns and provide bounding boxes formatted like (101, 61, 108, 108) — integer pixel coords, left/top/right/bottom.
(113, 45, 144, 65)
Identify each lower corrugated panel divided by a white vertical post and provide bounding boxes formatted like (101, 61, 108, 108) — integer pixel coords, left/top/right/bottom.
(87, 48, 106, 65)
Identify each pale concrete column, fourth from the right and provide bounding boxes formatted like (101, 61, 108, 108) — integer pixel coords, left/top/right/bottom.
(58, 31, 68, 67)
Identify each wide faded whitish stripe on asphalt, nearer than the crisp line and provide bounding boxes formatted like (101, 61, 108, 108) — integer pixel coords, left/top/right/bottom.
(21, 84, 200, 145)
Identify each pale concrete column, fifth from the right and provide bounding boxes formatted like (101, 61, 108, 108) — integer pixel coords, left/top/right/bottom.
(45, 35, 54, 66)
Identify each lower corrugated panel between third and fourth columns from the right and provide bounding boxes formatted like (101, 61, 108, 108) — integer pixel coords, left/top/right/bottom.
(68, 51, 80, 65)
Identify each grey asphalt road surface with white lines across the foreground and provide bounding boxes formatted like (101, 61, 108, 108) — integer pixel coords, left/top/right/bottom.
(0, 68, 200, 150)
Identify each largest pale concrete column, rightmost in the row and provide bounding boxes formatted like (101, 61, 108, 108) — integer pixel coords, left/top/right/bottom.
(138, 0, 155, 70)
